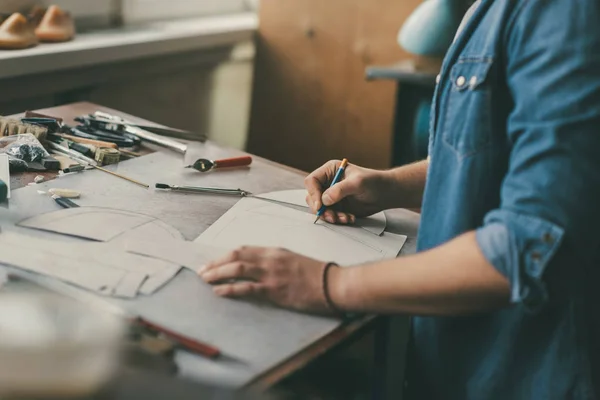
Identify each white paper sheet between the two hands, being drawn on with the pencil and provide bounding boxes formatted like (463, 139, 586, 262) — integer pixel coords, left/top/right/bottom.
(195, 198, 406, 265)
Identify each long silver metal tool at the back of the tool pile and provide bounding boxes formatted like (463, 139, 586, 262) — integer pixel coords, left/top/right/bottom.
(75, 111, 187, 154)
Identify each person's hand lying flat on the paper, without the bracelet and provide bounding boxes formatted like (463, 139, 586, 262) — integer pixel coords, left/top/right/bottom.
(199, 247, 330, 313)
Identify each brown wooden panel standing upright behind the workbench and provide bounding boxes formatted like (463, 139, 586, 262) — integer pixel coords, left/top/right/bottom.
(248, 0, 421, 171)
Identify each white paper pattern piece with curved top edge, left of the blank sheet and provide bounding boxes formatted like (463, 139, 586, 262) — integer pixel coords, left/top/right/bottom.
(18, 207, 183, 242)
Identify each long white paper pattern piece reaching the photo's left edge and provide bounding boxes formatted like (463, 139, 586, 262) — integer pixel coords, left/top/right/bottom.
(0, 232, 148, 297)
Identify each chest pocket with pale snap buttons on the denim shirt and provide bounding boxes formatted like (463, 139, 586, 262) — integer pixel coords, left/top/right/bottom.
(442, 58, 493, 157)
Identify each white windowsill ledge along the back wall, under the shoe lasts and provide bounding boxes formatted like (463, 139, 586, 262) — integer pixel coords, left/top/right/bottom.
(0, 12, 258, 79)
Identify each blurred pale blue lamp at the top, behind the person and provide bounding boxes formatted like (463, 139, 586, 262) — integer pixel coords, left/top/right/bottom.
(398, 0, 469, 58)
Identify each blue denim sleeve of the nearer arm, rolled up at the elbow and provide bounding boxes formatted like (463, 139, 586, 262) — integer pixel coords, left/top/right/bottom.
(476, 0, 600, 311)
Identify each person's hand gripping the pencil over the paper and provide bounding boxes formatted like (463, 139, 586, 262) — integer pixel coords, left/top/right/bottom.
(304, 160, 391, 224)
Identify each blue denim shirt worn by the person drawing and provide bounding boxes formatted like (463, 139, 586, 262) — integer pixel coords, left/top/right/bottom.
(406, 0, 600, 400)
